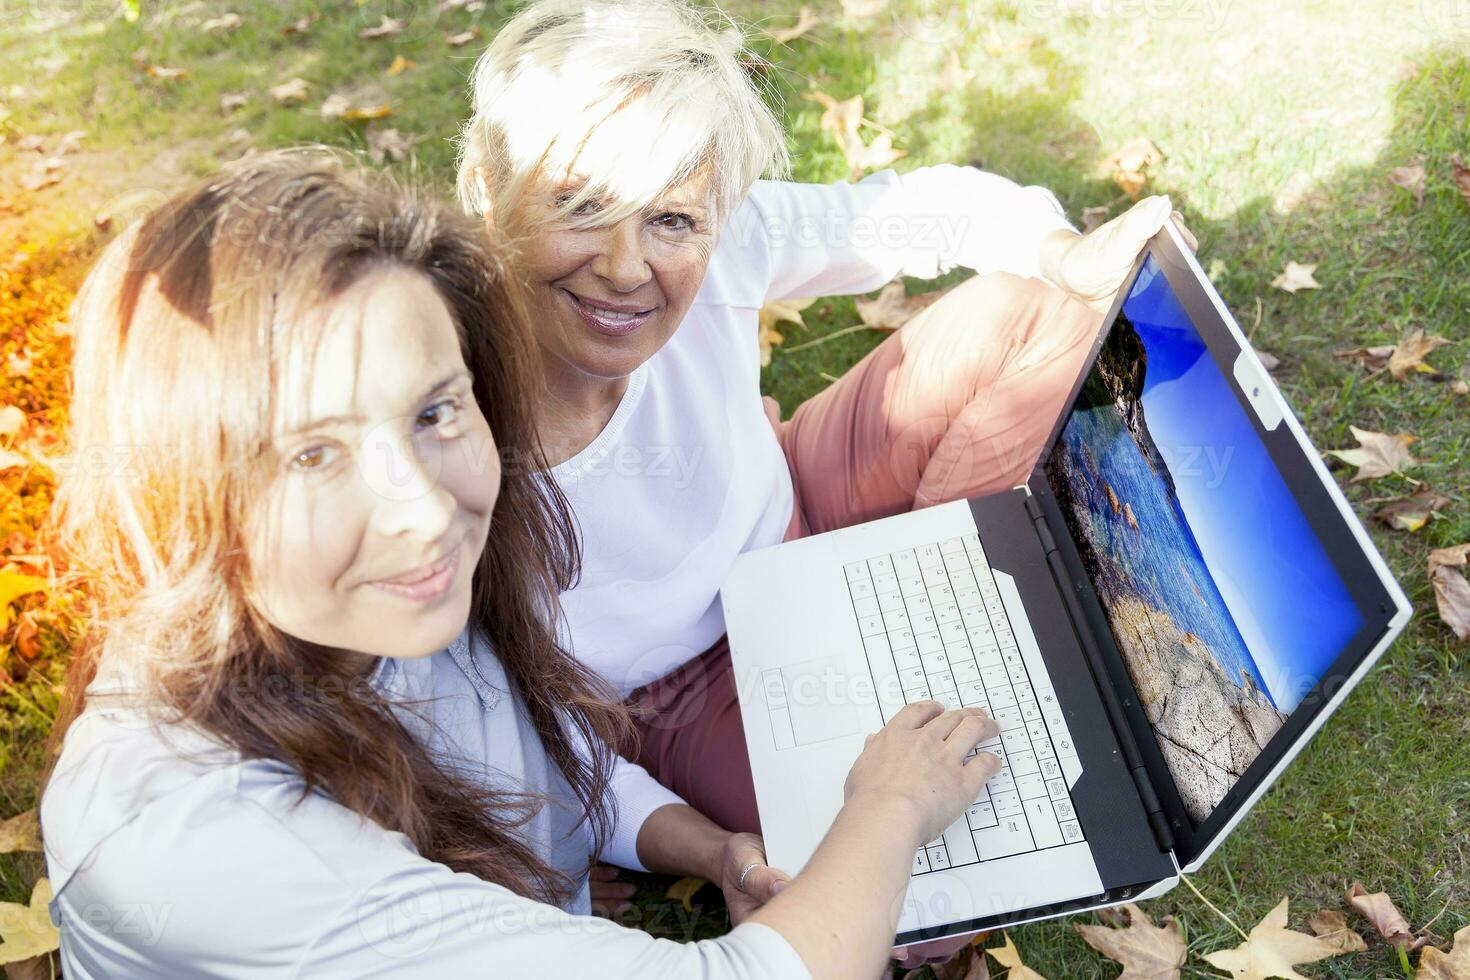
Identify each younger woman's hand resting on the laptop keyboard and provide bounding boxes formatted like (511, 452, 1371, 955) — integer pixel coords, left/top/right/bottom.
(844, 701, 1001, 851)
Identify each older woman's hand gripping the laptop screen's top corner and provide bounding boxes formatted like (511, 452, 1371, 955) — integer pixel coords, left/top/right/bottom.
(1041, 195, 1200, 313)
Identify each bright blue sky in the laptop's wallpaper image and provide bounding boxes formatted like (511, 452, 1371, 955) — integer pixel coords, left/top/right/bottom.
(1123, 257, 1363, 711)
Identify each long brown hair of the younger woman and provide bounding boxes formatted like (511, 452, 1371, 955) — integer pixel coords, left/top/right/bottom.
(47, 148, 628, 901)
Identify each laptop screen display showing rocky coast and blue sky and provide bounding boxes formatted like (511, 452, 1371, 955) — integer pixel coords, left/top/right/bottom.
(1045, 256, 1364, 827)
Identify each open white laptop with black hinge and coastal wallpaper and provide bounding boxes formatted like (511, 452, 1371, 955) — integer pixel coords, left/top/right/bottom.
(722, 226, 1410, 943)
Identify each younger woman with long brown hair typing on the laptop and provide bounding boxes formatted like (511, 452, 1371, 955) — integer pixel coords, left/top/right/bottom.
(41, 151, 997, 980)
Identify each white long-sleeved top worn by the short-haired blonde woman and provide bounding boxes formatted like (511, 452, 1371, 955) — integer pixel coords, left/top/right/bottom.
(553, 165, 1072, 693)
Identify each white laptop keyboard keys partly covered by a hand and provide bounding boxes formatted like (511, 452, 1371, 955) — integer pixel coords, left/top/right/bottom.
(844, 533, 1085, 874)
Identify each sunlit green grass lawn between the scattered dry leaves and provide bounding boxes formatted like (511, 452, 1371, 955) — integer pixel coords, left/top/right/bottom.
(0, 0, 1470, 980)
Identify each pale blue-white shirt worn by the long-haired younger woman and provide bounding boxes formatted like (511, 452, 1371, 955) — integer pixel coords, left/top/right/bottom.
(41, 633, 809, 980)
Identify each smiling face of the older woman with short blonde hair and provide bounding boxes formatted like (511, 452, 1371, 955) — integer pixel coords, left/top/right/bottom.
(522, 164, 719, 383)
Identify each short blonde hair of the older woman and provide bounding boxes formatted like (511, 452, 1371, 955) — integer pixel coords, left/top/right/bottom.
(457, 0, 789, 223)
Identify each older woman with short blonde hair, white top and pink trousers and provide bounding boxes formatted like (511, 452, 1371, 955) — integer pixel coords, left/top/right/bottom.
(459, 0, 1177, 963)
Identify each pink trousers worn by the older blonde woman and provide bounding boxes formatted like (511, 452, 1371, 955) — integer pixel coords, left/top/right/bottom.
(628, 273, 1103, 833)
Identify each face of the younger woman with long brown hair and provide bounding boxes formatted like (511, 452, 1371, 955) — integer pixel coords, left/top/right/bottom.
(250, 266, 500, 667)
